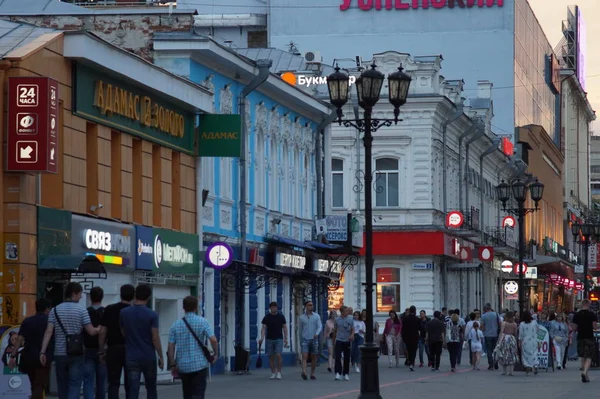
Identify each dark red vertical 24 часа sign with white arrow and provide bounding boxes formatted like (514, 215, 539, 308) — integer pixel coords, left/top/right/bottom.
(6, 77, 58, 173)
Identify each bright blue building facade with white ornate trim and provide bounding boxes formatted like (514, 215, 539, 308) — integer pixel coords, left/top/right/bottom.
(154, 34, 329, 372)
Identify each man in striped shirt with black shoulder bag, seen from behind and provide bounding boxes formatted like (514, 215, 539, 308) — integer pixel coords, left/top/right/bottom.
(39, 283, 99, 399)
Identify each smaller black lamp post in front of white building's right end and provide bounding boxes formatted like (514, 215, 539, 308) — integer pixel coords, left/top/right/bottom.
(496, 179, 544, 317)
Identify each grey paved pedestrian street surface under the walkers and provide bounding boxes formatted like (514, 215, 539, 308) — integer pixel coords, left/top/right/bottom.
(51, 352, 600, 399)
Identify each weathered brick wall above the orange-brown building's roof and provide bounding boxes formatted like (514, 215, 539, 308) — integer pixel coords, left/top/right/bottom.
(11, 14, 194, 61)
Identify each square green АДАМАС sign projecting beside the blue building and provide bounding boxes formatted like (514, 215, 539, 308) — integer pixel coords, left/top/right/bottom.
(198, 114, 242, 158)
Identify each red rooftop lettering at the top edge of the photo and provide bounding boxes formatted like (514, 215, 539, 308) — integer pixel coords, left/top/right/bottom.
(340, 0, 504, 11)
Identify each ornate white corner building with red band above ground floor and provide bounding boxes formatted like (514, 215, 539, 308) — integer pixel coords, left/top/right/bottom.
(324, 52, 515, 321)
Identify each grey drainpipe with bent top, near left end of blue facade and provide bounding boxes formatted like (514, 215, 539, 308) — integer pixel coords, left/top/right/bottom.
(236, 56, 273, 348)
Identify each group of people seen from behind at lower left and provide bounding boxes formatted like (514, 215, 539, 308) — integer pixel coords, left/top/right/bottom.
(7, 282, 218, 399)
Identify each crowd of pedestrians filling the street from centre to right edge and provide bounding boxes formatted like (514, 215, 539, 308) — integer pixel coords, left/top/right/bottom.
(259, 300, 598, 382)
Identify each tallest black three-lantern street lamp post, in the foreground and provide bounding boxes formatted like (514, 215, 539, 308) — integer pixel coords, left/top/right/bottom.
(327, 64, 411, 399)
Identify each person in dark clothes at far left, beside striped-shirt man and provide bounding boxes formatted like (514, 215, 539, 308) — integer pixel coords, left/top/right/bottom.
(8, 298, 54, 399)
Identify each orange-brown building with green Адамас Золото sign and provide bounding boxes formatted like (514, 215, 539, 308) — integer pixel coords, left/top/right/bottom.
(0, 25, 212, 384)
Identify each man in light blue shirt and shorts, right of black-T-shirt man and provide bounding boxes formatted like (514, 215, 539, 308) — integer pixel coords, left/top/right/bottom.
(298, 301, 324, 380)
